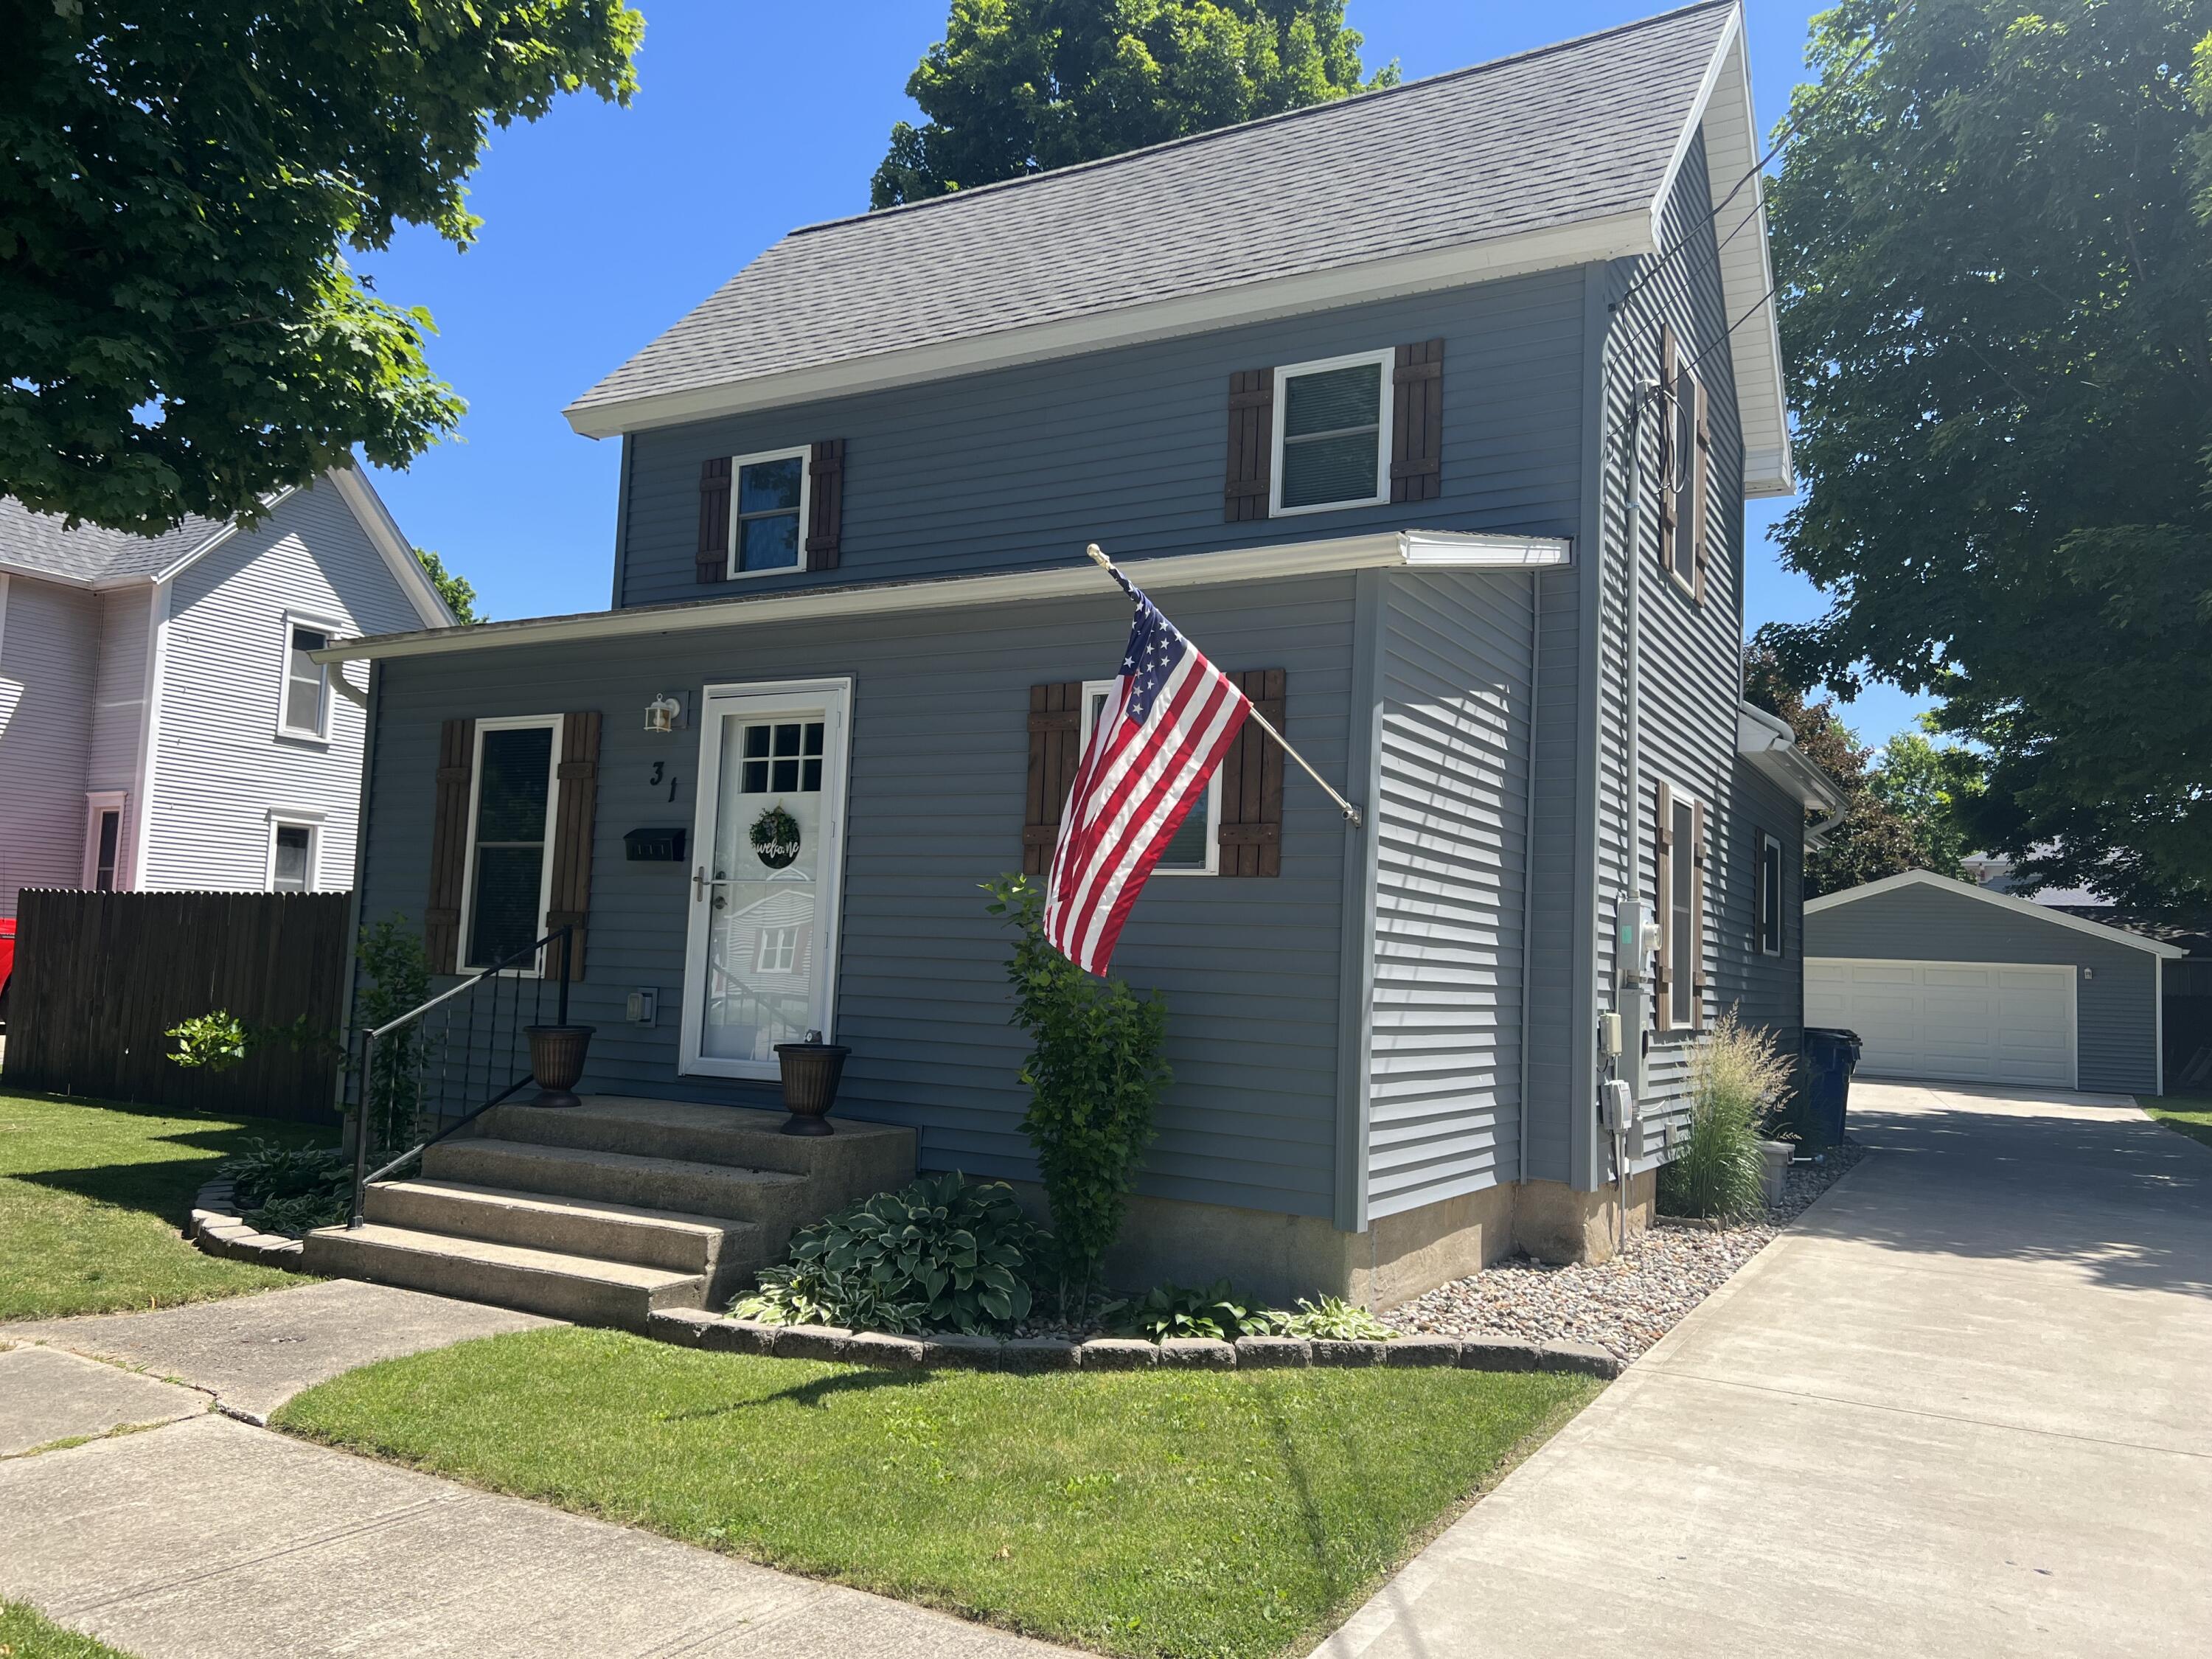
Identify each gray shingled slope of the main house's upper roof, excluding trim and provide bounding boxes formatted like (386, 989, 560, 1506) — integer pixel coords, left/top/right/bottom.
(573, 0, 1732, 429)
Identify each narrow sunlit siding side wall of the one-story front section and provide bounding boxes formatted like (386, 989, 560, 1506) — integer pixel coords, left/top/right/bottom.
(1367, 573, 1535, 1217)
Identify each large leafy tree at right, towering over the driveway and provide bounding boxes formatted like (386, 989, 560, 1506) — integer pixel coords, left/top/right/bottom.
(1765, 0, 2212, 911)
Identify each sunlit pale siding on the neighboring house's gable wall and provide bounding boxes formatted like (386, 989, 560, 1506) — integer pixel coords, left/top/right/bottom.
(142, 484, 420, 889)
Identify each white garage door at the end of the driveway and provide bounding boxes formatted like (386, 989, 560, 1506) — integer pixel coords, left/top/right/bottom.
(1805, 956, 2075, 1088)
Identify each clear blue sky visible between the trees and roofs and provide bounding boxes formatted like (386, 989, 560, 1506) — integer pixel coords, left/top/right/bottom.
(361, 0, 1920, 743)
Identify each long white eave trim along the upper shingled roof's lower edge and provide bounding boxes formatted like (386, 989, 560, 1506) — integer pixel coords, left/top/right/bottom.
(562, 208, 1655, 438)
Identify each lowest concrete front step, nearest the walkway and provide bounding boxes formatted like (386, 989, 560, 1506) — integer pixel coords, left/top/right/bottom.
(301, 1221, 706, 1332)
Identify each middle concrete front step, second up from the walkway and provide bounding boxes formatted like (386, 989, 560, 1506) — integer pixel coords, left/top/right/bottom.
(363, 1181, 772, 1301)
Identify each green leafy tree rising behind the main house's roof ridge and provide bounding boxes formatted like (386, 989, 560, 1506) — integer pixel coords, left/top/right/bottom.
(869, 0, 1398, 208)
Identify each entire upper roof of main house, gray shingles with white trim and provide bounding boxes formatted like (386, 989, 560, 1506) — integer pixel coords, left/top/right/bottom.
(566, 0, 1787, 489)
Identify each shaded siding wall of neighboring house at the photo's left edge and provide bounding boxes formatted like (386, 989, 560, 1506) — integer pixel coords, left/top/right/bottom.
(0, 575, 100, 916)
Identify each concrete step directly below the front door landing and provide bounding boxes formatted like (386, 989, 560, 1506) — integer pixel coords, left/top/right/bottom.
(422, 1137, 810, 1248)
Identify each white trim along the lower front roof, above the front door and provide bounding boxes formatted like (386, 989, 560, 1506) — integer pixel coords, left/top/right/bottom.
(314, 531, 1573, 661)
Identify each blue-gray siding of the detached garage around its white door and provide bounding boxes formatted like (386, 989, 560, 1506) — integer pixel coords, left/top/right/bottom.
(1805, 883, 2159, 1095)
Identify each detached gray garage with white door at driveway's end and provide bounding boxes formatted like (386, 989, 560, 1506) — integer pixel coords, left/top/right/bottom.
(1805, 869, 2181, 1095)
